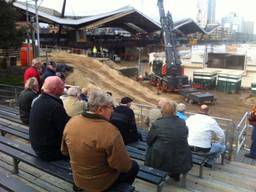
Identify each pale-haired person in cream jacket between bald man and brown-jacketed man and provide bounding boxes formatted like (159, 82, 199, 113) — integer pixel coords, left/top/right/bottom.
(63, 86, 87, 117)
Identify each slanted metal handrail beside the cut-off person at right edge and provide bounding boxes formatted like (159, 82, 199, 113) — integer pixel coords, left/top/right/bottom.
(236, 112, 251, 156)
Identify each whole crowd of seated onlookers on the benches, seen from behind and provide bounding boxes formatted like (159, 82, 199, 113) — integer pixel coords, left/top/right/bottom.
(19, 59, 256, 191)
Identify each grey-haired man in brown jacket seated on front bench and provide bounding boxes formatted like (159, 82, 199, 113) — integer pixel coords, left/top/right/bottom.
(61, 90, 139, 191)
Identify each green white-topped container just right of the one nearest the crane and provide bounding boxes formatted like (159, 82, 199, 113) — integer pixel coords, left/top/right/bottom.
(217, 74, 241, 93)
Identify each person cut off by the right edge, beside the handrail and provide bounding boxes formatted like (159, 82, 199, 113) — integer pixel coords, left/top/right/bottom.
(244, 106, 256, 159)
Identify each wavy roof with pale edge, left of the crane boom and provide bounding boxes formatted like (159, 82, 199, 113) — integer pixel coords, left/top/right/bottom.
(13, 2, 161, 32)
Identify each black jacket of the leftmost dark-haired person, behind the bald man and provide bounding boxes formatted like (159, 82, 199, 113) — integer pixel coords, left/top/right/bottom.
(19, 89, 38, 125)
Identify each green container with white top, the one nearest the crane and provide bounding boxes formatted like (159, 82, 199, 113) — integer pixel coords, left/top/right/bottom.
(193, 71, 217, 89)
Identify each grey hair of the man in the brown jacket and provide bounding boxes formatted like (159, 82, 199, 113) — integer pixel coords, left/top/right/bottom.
(88, 90, 113, 112)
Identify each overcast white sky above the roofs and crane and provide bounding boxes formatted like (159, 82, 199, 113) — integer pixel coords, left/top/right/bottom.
(22, 0, 256, 22)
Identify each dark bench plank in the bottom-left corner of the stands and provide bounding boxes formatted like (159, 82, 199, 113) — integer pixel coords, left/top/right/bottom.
(0, 172, 37, 192)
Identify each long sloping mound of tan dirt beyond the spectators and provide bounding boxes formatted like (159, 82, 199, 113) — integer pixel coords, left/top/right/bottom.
(48, 52, 180, 104)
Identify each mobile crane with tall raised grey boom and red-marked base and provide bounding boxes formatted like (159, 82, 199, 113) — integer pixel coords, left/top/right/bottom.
(151, 0, 188, 91)
